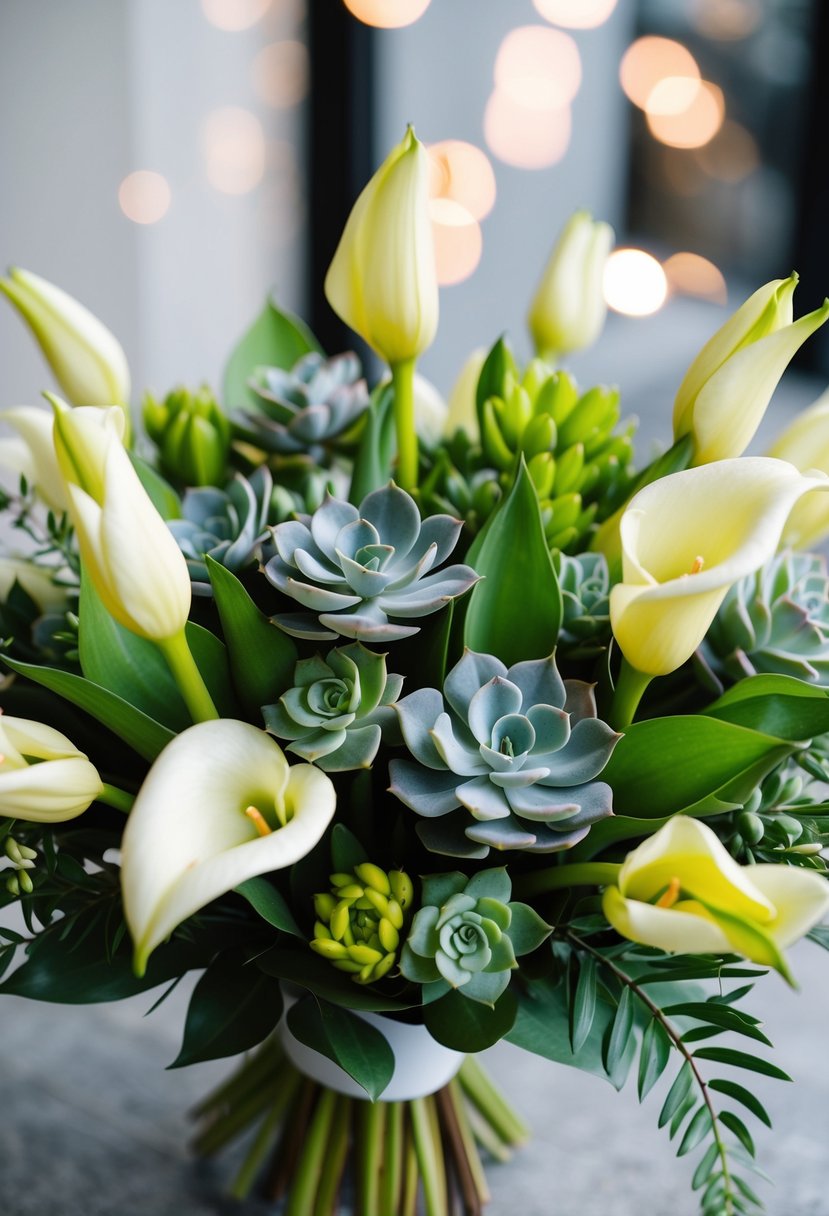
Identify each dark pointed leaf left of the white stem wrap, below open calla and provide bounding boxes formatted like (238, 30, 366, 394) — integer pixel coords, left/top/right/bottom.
(168, 951, 282, 1069)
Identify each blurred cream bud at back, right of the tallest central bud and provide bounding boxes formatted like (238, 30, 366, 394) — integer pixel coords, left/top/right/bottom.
(528, 212, 614, 362)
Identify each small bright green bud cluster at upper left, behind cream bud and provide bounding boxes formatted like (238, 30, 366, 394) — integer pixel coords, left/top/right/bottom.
(142, 384, 231, 485)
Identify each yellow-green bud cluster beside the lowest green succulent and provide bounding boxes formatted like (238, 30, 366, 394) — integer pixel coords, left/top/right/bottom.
(310, 861, 415, 984)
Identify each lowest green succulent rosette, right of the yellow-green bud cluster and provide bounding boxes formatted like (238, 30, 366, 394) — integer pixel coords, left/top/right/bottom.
(400, 866, 552, 1006)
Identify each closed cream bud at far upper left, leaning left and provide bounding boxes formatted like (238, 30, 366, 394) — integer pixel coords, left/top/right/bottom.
(0, 268, 130, 406)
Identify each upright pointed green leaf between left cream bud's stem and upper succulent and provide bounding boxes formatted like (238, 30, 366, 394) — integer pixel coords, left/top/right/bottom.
(205, 557, 298, 717)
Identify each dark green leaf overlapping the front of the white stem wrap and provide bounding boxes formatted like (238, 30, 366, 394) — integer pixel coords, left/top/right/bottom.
(288, 997, 394, 1102)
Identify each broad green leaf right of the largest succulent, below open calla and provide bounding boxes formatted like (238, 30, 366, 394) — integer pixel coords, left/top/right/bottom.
(602, 714, 794, 822)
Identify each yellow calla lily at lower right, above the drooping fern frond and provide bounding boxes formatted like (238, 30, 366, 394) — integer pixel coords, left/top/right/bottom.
(603, 815, 829, 979)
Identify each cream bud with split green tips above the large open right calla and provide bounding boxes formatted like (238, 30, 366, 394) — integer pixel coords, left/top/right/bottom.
(673, 274, 829, 465)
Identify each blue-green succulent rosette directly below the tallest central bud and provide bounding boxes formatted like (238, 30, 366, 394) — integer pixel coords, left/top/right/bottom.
(265, 483, 478, 642)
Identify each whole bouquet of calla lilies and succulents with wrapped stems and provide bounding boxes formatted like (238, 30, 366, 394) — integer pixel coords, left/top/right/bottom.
(0, 131, 829, 1216)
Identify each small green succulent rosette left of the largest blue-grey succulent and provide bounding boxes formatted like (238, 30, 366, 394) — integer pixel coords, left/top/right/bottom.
(263, 642, 404, 772)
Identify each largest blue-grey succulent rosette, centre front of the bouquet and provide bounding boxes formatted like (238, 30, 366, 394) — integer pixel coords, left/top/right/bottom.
(390, 651, 620, 857)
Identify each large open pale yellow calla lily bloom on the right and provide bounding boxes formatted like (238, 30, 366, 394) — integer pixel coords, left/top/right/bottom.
(610, 456, 829, 676)
